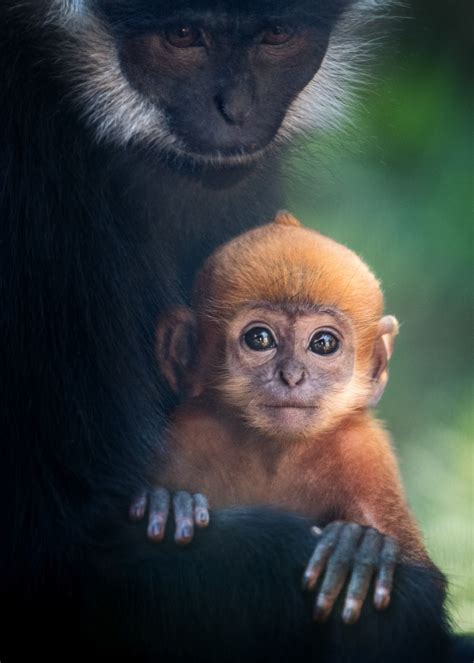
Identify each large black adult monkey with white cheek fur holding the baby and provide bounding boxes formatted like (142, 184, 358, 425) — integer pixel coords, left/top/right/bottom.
(0, 0, 454, 663)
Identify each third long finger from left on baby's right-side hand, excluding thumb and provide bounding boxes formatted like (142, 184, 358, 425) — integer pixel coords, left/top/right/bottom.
(342, 529, 382, 624)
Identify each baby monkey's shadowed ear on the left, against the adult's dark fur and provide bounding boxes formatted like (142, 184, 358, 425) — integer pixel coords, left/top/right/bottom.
(156, 306, 197, 396)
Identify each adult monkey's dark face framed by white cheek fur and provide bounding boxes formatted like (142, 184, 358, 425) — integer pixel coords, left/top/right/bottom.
(57, 0, 350, 165)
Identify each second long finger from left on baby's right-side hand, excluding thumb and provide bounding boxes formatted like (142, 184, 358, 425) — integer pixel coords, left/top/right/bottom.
(314, 523, 363, 622)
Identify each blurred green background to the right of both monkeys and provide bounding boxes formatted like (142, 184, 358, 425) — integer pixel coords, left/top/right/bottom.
(289, 0, 474, 631)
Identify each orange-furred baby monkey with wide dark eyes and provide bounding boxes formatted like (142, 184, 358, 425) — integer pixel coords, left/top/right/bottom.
(149, 213, 431, 623)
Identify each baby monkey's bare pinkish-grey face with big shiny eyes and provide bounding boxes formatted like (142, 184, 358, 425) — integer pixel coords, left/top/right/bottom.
(222, 304, 355, 437)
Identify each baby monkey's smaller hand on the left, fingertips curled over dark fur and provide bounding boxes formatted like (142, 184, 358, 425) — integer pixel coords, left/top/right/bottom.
(129, 487, 209, 545)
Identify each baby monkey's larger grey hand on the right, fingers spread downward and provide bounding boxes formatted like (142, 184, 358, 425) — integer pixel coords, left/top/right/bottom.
(303, 521, 398, 624)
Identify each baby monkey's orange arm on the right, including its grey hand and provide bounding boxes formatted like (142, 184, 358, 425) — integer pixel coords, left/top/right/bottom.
(304, 413, 431, 623)
